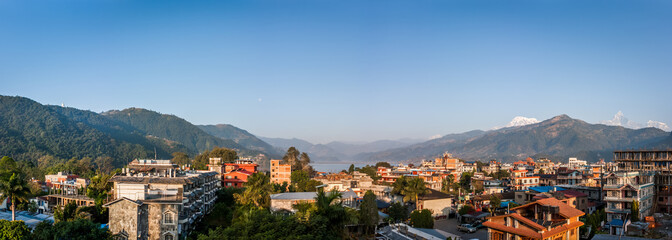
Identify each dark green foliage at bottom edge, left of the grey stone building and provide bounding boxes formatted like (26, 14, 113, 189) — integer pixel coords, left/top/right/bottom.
(31, 219, 112, 240)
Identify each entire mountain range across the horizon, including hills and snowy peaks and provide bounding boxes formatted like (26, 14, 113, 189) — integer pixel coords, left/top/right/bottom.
(0, 96, 672, 166)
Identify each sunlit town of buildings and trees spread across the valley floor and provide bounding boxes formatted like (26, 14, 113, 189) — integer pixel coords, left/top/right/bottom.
(0, 147, 672, 240)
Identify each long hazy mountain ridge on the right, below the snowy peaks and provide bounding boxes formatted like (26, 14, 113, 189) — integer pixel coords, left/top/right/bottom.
(360, 115, 670, 162)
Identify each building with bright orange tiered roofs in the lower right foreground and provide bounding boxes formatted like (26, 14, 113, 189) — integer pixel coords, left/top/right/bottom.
(483, 198, 584, 240)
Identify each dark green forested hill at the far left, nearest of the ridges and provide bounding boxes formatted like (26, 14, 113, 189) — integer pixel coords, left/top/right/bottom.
(0, 96, 187, 166)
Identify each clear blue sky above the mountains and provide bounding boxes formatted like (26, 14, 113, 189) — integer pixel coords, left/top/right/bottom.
(0, 0, 672, 143)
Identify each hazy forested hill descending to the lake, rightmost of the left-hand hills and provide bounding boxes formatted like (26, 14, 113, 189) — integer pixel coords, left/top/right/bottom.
(196, 124, 283, 158)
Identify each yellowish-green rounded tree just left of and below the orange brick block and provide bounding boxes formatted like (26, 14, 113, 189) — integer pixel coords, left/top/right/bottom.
(234, 172, 273, 208)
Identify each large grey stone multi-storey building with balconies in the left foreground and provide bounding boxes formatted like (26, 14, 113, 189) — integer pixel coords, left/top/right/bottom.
(104, 160, 221, 240)
